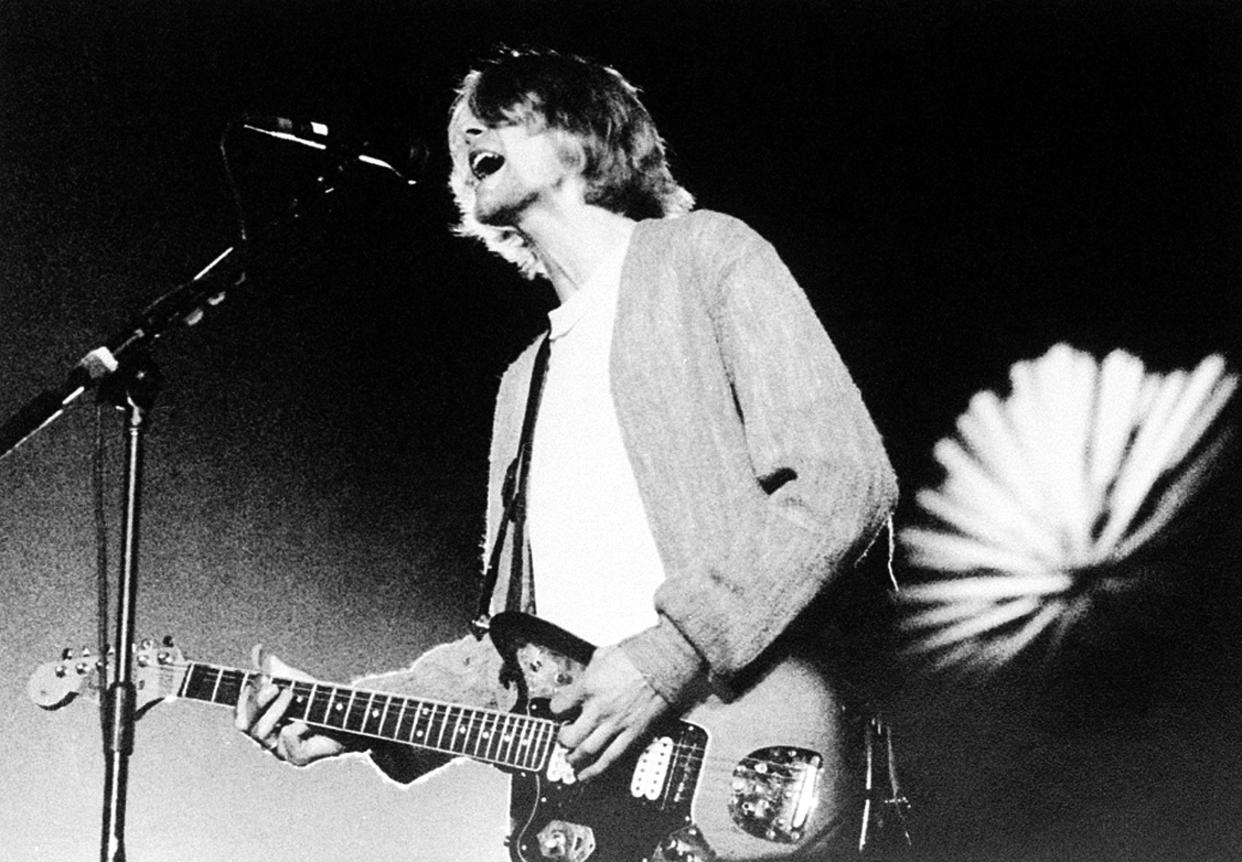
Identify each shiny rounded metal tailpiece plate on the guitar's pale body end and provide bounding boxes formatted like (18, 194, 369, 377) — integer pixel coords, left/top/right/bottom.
(729, 746, 823, 843)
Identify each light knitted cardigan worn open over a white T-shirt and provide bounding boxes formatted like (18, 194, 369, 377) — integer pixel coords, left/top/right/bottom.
(484, 210, 897, 703)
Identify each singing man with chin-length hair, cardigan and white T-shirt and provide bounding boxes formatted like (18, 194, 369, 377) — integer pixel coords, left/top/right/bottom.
(236, 51, 897, 862)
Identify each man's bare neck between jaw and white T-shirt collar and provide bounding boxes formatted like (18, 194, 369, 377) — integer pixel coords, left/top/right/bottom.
(519, 184, 635, 303)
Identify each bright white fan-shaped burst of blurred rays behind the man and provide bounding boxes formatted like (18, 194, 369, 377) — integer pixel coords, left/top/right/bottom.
(898, 344, 1238, 672)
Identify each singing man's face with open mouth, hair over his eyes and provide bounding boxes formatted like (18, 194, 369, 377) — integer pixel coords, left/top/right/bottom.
(448, 102, 573, 227)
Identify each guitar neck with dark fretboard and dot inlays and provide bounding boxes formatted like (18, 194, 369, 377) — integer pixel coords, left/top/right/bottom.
(169, 662, 559, 771)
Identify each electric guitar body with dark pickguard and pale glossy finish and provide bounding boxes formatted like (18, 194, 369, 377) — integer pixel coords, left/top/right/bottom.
(492, 614, 861, 862)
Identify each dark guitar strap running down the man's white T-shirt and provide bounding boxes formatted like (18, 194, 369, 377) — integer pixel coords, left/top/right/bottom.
(471, 334, 551, 640)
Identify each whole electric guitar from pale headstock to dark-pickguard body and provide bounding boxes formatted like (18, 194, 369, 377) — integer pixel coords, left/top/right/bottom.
(29, 614, 857, 862)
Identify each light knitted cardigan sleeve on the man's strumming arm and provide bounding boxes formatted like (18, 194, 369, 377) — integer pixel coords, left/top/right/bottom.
(623, 221, 897, 702)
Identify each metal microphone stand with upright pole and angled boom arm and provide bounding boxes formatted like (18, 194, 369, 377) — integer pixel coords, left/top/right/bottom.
(0, 121, 415, 862)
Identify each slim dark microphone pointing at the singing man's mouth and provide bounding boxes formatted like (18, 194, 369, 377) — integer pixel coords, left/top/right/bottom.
(240, 114, 427, 185)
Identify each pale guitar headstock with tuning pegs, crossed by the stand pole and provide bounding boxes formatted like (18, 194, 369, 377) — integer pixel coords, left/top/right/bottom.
(26, 637, 189, 712)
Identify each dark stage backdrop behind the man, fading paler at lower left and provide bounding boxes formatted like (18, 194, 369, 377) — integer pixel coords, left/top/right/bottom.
(0, 0, 1242, 860)
